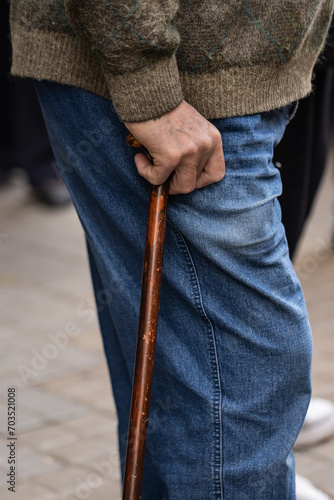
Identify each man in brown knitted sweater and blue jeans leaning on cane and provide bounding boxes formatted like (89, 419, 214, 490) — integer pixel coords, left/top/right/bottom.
(11, 0, 333, 500)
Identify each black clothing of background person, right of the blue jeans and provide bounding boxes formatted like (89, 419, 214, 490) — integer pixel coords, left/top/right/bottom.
(274, 23, 334, 258)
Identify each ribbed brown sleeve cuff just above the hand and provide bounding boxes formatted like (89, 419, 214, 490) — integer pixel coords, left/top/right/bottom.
(104, 55, 183, 122)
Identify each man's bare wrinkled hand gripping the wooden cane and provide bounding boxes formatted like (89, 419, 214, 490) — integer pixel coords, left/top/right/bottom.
(125, 101, 225, 194)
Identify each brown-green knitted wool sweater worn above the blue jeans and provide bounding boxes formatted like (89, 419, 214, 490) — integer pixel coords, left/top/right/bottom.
(11, 0, 334, 121)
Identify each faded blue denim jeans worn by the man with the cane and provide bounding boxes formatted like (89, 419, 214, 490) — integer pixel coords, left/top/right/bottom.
(37, 82, 312, 500)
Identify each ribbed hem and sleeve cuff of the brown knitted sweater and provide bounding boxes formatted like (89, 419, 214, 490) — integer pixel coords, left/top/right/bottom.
(11, 28, 317, 122)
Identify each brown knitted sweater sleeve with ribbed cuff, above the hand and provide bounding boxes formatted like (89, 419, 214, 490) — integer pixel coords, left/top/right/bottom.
(65, 0, 183, 122)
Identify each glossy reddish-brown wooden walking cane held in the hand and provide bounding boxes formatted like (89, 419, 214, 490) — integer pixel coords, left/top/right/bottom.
(122, 134, 169, 500)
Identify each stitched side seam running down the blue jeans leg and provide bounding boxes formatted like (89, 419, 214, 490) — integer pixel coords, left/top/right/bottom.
(167, 219, 223, 500)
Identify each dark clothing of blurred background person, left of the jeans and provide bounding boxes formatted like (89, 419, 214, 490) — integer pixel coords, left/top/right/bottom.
(0, 0, 58, 186)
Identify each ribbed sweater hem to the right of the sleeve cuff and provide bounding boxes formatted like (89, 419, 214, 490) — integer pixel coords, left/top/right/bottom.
(180, 58, 316, 119)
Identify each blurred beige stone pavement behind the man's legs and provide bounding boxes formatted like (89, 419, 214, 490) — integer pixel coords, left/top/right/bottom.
(0, 155, 334, 500)
